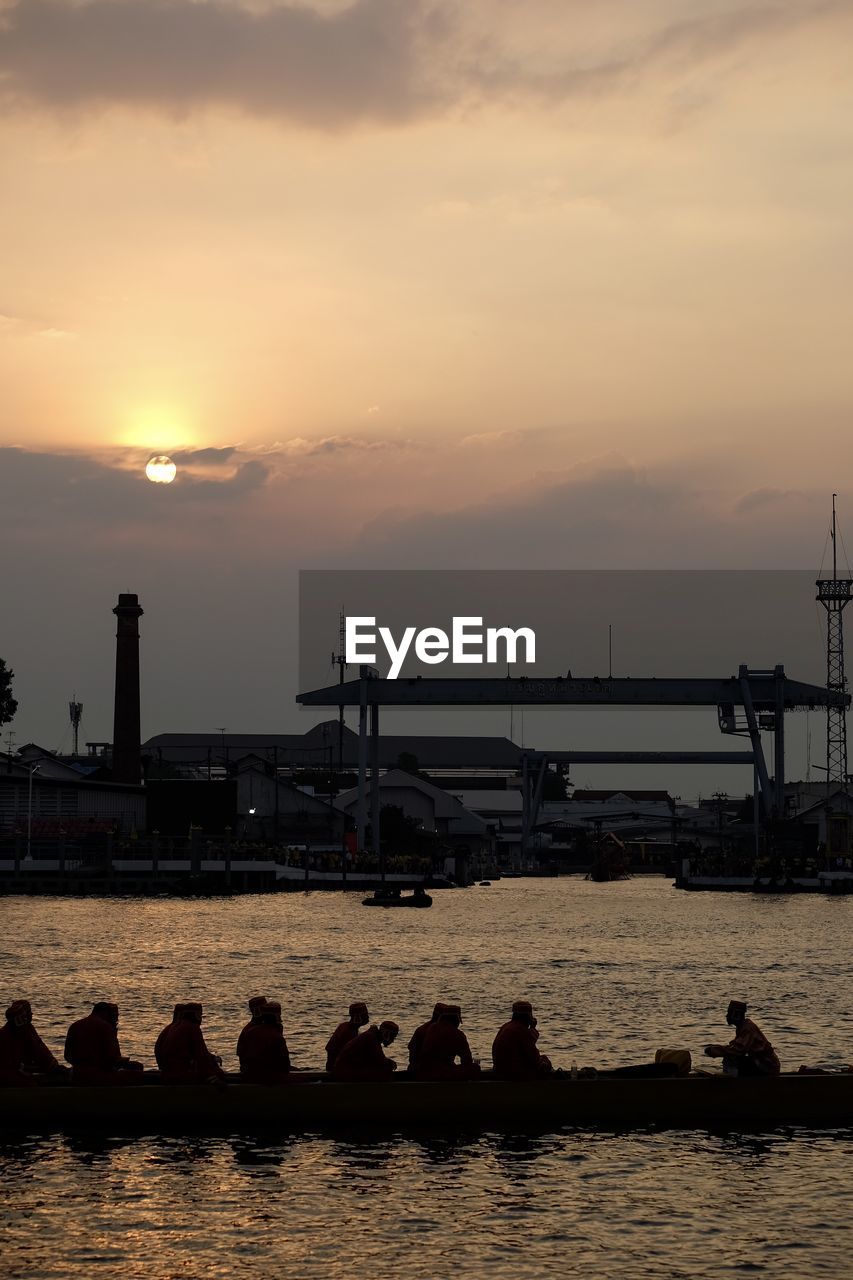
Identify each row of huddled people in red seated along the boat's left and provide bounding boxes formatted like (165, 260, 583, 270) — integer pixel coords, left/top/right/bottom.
(0, 996, 552, 1085)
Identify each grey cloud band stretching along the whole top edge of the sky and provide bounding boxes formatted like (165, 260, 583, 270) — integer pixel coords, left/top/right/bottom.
(0, 0, 835, 129)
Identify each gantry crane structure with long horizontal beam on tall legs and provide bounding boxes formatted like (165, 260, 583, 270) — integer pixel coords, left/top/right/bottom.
(296, 664, 850, 854)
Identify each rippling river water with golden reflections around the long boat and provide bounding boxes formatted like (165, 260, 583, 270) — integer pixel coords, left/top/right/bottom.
(0, 878, 853, 1280)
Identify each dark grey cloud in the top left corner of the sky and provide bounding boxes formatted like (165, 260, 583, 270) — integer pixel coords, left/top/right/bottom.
(0, 0, 433, 128)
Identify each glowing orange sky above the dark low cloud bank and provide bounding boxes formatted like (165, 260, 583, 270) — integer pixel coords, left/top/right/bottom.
(0, 0, 853, 479)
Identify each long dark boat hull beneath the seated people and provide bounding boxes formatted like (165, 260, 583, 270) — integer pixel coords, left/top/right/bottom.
(0, 1073, 853, 1134)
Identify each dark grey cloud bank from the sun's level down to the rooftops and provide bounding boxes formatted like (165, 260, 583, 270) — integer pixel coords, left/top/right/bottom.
(0, 449, 835, 752)
